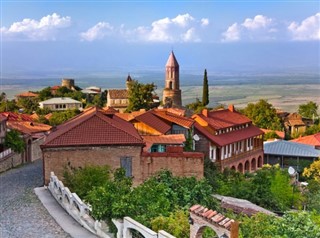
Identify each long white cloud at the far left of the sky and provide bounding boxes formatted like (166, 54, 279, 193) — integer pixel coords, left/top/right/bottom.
(1, 13, 71, 41)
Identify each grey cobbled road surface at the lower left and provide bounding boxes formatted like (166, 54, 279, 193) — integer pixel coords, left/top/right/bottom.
(0, 160, 70, 238)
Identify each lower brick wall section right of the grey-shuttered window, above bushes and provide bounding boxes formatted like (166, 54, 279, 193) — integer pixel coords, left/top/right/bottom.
(141, 147, 204, 180)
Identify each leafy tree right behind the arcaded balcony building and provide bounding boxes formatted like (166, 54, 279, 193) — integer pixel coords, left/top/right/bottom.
(242, 99, 282, 131)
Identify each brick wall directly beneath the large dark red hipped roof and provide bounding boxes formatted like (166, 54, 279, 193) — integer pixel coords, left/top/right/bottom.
(42, 146, 142, 184)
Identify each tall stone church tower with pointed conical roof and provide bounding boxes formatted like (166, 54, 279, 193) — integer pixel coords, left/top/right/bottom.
(162, 51, 182, 107)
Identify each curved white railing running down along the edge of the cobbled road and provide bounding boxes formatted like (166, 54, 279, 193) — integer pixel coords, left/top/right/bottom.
(48, 172, 111, 238)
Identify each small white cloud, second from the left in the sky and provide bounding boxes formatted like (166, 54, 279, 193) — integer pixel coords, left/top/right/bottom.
(80, 22, 113, 41)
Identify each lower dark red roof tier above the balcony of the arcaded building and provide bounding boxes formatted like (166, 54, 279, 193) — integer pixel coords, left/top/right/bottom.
(194, 122, 263, 146)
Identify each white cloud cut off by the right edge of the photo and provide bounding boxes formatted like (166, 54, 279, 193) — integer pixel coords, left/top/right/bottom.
(288, 12, 320, 41)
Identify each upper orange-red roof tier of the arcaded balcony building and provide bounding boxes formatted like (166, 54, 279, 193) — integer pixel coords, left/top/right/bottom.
(192, 109, 251, 130)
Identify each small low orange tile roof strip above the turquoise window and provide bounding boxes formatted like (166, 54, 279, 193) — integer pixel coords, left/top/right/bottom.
(142, 134, 186, 152)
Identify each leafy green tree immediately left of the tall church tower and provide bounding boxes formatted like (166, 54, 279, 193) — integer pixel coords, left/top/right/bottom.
(126, 80, 156, 112)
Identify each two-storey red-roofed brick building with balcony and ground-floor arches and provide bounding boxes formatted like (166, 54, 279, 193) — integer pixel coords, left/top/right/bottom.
(192, 105, 263, 173)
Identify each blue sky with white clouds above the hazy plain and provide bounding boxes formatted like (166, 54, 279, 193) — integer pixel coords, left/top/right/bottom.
(0, 0, 320, 77)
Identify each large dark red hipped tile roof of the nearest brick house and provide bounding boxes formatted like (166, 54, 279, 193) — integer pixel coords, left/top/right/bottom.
(43, 107, 144, 148)
